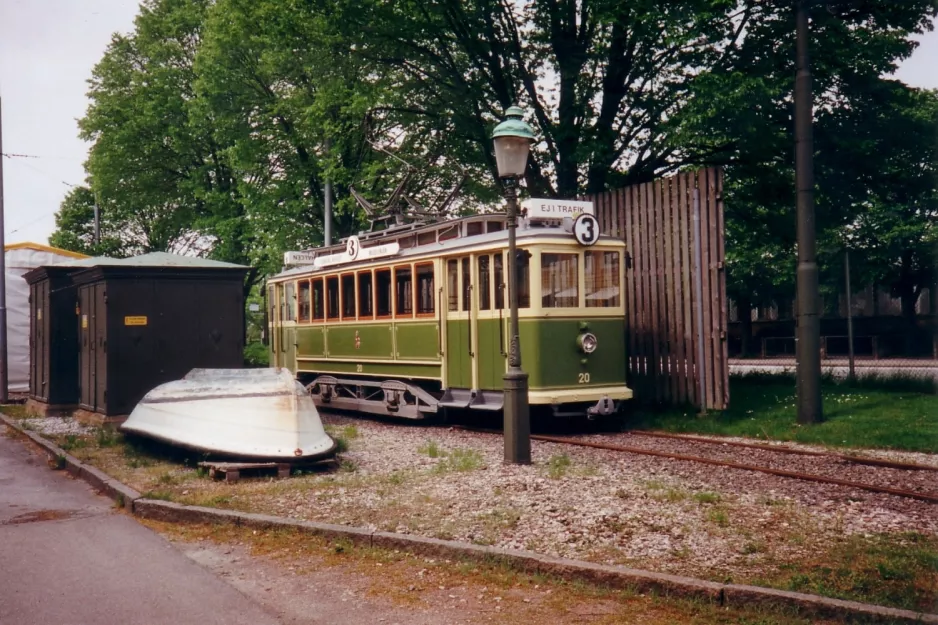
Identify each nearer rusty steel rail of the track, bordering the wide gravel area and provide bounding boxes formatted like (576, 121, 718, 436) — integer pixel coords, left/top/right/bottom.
(453, 426, 938, 503)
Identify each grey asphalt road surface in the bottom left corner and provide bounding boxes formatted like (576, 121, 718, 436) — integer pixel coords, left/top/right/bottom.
(0, 425, 280, 625)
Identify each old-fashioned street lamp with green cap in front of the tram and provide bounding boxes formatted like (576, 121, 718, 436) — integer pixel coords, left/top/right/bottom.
(492, 106, 534, 464)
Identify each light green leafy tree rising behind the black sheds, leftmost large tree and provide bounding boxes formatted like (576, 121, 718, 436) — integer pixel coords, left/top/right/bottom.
(53, 0, 250, 262)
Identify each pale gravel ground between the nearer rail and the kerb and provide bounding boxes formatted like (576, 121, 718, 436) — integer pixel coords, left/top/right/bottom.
(219, 415, 938, 579)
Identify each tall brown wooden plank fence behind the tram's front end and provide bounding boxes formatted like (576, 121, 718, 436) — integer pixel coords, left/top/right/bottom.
(584, 168, 730, 410)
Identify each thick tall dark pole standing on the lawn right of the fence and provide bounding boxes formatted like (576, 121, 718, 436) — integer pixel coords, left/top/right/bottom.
(795, 0, 823, 423)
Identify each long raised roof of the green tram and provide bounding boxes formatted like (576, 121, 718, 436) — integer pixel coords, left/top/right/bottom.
(271, 213, 624, 279)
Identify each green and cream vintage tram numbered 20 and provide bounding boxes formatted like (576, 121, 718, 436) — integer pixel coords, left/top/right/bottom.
(267, 214, 632, 419)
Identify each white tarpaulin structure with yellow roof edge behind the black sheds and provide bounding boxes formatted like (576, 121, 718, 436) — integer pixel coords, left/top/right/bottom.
(6, 243, 86, 392)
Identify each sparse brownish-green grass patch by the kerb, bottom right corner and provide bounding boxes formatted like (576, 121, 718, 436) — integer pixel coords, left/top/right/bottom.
(756, 533, 938, 612)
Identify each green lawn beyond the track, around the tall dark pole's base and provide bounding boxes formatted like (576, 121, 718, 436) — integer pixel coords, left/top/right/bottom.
(634, 375, 938, 453)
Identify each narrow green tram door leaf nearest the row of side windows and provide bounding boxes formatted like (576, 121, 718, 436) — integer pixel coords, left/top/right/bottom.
(445, 256, 477, 389)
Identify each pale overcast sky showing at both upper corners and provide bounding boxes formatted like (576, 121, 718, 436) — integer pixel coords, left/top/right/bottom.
(0, 0, 938, 244)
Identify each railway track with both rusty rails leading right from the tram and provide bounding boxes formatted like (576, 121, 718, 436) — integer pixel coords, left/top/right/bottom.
(455, 426, 938, 504)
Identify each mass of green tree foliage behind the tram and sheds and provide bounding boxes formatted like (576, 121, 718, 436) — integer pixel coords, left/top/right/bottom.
(54, 0, 938, 312)
